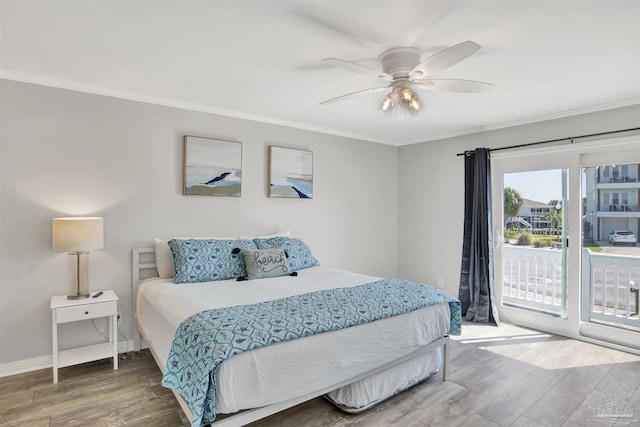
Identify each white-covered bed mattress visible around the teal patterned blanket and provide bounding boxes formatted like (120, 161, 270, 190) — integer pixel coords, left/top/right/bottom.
(136, 266, 450, 413)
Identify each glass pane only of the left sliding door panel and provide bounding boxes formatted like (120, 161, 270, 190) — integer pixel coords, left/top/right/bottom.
(502, 168, 567, 318)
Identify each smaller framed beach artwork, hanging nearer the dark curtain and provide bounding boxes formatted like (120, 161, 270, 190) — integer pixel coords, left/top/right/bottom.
(269, 145, 313, 199)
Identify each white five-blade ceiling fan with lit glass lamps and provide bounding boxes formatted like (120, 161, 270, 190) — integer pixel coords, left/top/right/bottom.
(320, 40, 494, 116)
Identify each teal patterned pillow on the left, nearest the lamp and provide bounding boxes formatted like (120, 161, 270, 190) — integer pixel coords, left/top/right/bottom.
(168, 239, 256, 283)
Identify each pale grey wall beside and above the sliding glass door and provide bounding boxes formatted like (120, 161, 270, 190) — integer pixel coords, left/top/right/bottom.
(398, 106, 640, 296)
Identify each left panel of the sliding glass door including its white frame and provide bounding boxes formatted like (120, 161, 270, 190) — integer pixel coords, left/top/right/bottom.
(492, 154, 578, 334)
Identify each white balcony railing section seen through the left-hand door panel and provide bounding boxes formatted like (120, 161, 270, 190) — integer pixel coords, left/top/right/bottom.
(502, 245, 564, 316)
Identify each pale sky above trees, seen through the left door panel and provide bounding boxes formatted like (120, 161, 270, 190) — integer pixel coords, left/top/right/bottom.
(504, 169, 562, 203)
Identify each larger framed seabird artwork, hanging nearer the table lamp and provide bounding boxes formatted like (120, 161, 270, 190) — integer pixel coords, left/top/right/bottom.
(183, 135, 242, 197)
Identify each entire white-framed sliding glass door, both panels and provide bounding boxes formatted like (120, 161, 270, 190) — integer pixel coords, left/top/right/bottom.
(492, 136, 640, 348)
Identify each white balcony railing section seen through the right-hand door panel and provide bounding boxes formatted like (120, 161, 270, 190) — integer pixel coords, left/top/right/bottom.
(582, 249, 640, 331)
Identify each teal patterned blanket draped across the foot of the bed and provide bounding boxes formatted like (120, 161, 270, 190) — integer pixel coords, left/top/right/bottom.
(162, 279, 461, 427)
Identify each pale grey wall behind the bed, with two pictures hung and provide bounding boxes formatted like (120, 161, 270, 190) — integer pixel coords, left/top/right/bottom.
(0, 80, 398, 367)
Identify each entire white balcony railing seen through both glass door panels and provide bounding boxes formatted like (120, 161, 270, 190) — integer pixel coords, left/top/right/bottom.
(502, 245, 640, 331)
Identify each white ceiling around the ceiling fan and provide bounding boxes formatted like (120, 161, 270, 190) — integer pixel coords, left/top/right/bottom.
(0, 0, 640, 145)
